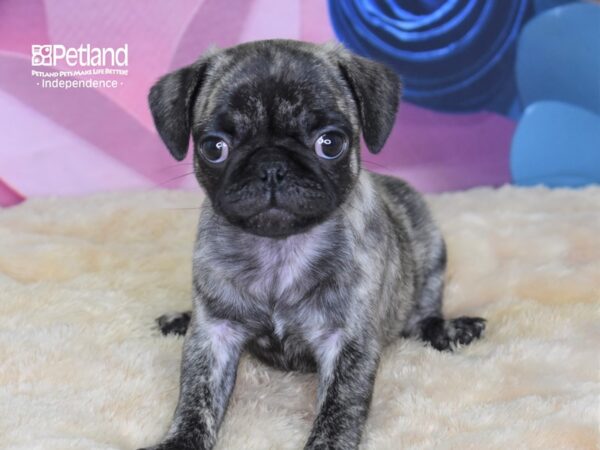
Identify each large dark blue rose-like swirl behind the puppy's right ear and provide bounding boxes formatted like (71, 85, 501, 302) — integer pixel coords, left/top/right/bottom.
(329, 0, 532, 112)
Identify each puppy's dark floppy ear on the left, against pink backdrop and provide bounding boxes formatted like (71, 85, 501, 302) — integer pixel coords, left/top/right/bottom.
(148, 58, 208, 161)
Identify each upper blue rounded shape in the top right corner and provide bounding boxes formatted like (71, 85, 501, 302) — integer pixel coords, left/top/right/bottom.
(516, 2, 600, 114)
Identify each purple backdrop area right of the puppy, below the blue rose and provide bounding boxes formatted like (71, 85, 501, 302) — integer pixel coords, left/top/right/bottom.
(363, 103, 515, 192)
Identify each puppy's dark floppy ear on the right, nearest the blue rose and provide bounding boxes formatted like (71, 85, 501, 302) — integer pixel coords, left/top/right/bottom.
(338, 53, 402, 153)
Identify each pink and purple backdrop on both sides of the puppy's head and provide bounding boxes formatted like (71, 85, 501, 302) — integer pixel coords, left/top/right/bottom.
(0, 0, 514, 205)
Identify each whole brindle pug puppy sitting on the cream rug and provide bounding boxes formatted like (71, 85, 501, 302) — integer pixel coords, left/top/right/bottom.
(139, 40, 485, 450)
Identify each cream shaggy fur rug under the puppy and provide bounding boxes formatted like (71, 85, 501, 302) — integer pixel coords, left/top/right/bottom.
(0, 187, 600, 450)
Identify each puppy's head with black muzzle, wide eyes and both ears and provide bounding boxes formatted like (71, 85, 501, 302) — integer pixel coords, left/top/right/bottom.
(149, 40, 400, 237)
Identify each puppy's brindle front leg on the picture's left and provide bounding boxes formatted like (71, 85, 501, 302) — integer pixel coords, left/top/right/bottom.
(139, 315, 246, 450)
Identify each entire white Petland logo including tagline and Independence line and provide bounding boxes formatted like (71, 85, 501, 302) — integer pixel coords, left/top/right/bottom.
(31, 44, 129, 89)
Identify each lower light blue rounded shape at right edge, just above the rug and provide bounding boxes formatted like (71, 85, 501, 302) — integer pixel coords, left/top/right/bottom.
(510, 101, 600, 187)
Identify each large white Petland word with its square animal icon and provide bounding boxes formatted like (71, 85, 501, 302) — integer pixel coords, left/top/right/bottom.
(31, 44, 129, 67)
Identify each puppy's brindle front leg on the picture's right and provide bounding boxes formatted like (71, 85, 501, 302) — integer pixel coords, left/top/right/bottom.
(305, 332, 379, 450)
